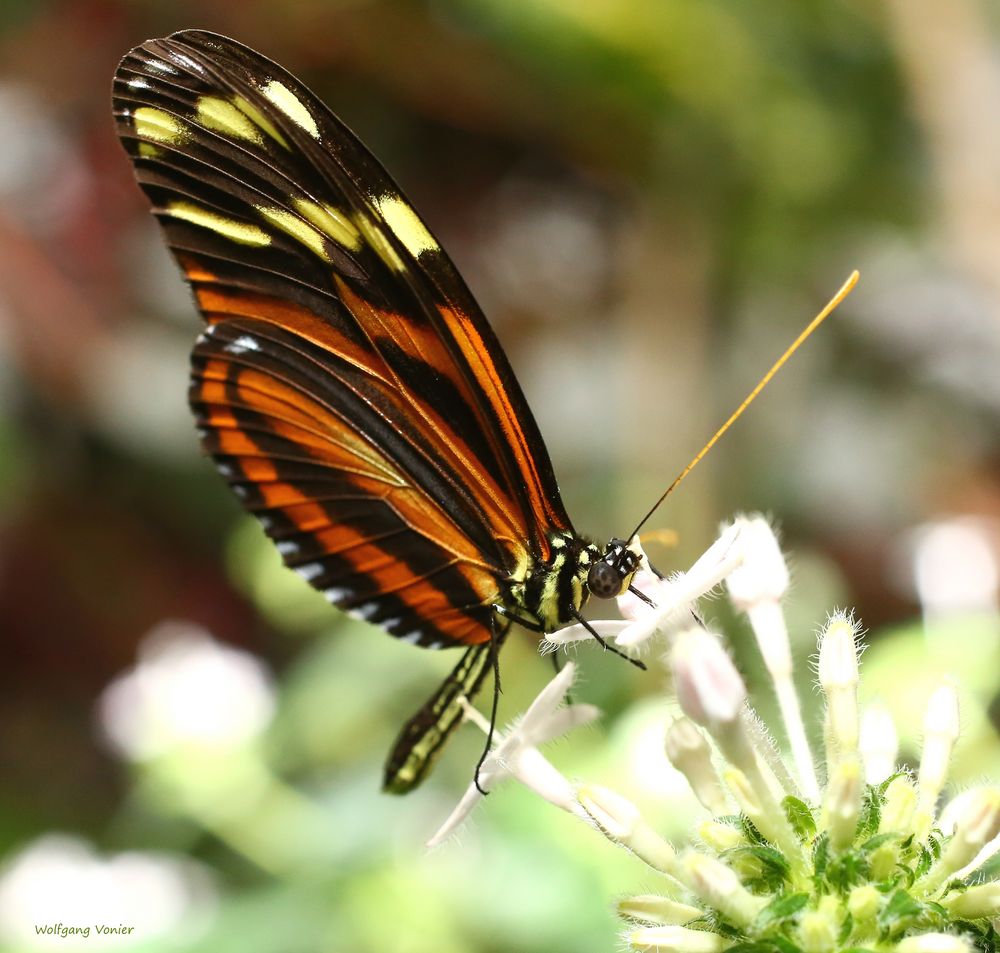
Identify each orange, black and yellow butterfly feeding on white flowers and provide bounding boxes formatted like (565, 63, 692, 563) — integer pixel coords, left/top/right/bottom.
(113, 30, 656, 792)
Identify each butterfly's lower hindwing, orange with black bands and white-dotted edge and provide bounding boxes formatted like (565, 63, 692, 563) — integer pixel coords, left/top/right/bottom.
(190, 318, 508, 647)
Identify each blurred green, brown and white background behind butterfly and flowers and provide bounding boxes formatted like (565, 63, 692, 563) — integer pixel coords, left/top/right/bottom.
(0, 0, 1000, 953)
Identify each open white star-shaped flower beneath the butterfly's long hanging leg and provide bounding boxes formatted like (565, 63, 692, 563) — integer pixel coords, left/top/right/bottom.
(427, 662, 600, 847)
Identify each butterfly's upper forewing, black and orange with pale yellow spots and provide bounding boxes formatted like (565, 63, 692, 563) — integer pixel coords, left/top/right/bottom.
(115, 31, 569, 562)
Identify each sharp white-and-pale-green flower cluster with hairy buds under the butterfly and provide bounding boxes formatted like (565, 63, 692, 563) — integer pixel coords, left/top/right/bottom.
(432, 517, 1000, 953)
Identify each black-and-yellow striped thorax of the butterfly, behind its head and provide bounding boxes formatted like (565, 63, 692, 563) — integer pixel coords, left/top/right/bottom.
(502, 532, 601, 632)
